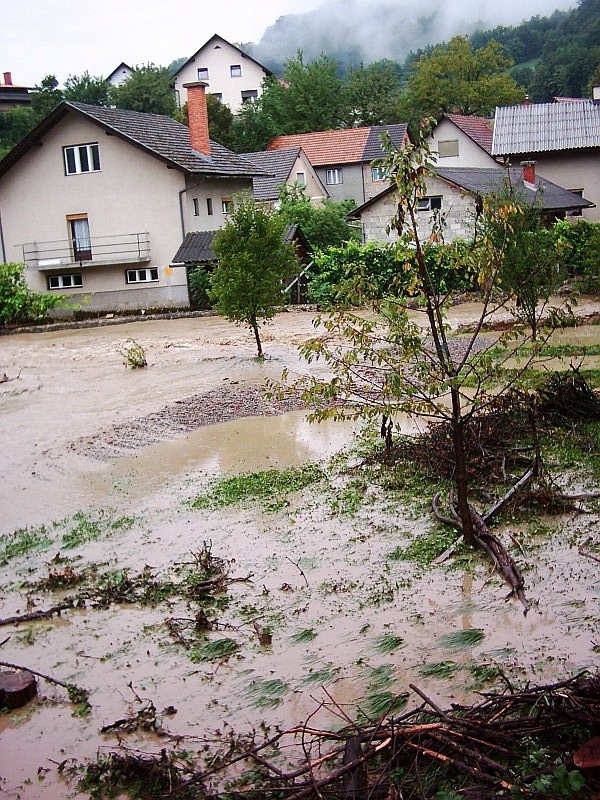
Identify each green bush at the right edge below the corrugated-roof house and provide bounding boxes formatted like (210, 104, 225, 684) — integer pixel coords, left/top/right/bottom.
(554, 219, 600, 292)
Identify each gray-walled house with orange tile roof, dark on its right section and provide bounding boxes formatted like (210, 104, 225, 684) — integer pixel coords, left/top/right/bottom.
(267, 124, 409, 205)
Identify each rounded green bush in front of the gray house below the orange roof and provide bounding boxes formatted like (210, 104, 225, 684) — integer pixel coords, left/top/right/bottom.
(278, 186, 359, 249)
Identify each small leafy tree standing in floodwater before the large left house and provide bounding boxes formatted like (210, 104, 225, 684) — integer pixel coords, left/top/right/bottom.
(210, 196, 298, 358)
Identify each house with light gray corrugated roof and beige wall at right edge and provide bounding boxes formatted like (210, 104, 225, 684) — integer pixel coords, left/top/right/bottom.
(492, 98, 600, 220)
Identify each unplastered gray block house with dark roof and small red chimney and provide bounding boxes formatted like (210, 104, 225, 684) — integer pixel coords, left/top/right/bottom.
(349, 166, 592, 242)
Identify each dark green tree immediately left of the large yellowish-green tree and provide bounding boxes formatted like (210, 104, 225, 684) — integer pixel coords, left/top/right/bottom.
(346, 59, 403, 126)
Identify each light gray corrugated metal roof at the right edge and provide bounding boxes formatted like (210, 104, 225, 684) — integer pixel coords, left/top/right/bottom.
(492, 100, 600, 155)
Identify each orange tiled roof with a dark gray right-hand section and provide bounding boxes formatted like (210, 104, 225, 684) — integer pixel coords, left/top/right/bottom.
(267, 123, 408, 167)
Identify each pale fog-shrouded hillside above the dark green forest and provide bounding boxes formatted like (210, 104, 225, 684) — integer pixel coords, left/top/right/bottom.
(251, 0, 576, 72)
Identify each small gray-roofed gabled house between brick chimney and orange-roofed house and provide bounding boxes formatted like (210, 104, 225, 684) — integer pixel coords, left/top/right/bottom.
(243, 147, 329, 206)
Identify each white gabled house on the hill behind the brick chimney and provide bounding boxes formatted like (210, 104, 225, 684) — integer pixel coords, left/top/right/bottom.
(173, 34, 272, 114)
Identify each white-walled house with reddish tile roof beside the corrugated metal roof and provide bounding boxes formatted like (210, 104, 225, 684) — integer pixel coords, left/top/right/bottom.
(429, 114, 497, 168)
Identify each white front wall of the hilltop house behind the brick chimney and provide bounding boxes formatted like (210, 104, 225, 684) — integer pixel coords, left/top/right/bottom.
(175, 39, 266, 114)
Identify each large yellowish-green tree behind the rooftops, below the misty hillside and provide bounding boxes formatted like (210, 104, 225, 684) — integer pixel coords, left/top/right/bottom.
(404, 36, 525, 126)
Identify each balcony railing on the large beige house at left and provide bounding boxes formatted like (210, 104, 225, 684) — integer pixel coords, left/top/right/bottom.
(23, 233, 150, 270)
